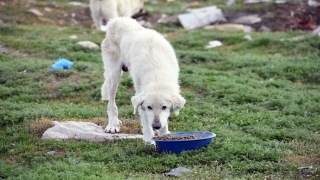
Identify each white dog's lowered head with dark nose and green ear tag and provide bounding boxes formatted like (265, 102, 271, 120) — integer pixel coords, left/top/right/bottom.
(131, 93, 186, 130)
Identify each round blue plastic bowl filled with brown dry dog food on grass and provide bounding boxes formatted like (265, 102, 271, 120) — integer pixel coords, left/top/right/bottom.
(152, 132, 216, 154)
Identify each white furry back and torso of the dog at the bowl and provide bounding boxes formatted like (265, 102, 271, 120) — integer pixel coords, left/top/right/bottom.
(102, 17, 179, 94)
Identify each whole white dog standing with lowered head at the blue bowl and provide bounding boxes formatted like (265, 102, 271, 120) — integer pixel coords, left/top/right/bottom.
(101, 17, 186, 143)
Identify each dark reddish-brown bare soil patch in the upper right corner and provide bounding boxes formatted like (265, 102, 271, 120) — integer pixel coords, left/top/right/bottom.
(224, 1, 320, 31)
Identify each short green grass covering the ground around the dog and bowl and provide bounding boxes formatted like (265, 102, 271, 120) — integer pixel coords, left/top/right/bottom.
(0, 0, 320, 179)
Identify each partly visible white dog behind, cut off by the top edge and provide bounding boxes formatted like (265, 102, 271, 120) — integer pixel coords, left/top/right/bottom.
(90, 0, 144, 30)
